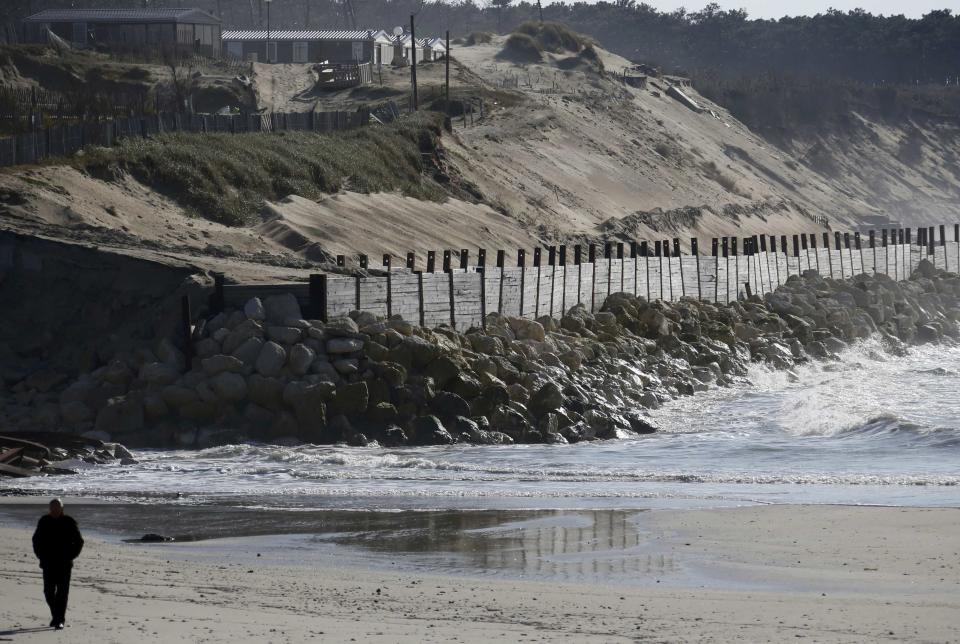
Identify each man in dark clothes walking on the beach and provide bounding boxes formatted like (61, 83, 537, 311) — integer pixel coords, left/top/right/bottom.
(33, 499, 83, 630)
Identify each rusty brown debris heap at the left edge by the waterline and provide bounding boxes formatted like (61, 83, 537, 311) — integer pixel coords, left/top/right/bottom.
(0, 432, 136, 477)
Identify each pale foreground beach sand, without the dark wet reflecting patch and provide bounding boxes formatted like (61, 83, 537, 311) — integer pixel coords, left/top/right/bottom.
(0, 500, 960, 643)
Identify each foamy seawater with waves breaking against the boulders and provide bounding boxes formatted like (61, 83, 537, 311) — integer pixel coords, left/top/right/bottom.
(4, 342, 960, 511)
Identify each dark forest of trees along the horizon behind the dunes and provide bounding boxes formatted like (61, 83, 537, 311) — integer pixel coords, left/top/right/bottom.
(0, 0, 960, 85)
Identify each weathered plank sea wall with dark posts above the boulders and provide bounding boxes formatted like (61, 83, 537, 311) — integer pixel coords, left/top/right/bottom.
(211, 224, 960, 329)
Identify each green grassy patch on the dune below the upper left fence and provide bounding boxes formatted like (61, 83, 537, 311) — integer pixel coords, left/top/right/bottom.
(78, 113, 445, 226)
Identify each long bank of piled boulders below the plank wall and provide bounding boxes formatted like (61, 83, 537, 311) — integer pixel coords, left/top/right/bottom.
(7, 262, 960, 447)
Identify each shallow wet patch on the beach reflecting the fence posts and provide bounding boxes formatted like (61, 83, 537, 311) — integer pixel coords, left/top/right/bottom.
(0, 504, 674, 583)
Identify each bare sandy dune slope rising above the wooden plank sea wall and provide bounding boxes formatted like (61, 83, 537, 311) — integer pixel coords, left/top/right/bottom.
(0, 32, 960, 270)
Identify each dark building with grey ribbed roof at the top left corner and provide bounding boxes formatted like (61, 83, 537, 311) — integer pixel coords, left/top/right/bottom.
(22, 9, 221, 56)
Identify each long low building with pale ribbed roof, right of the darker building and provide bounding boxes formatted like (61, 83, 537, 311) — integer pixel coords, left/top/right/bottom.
(223, 29, 393, 65)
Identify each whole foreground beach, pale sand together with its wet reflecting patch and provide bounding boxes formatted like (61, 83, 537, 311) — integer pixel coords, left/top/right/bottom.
(0, 506, 960, 642)
